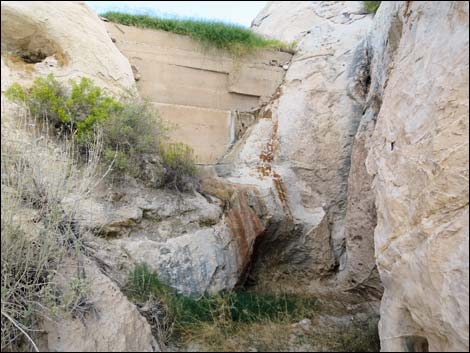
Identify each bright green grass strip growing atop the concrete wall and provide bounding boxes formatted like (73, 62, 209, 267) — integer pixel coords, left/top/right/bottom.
(102, 12, 291, 55)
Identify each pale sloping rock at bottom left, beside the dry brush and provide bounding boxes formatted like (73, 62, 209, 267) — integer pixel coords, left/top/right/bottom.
(40, 259, 161, 352)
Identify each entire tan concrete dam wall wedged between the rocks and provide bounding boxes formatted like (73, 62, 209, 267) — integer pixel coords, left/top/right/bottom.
(106, 22, 291, 164)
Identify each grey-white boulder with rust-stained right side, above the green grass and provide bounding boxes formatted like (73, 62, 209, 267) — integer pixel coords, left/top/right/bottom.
(78, 178, 264, 295)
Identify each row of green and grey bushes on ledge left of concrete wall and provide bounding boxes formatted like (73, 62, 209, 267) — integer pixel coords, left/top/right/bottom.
(5, 75, 196, 191)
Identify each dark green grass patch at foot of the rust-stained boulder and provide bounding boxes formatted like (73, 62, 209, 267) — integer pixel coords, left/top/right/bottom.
(124, 264, 316, 336)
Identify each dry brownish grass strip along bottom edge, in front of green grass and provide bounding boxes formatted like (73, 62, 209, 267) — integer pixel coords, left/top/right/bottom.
(176, 313, 380, 352)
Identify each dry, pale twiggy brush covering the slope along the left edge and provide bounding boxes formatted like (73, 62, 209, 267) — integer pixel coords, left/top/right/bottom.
(1, 102, 102, 351)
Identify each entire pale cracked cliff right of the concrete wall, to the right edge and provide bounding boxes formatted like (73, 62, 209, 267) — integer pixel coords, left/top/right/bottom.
(248, 2, 469, 350)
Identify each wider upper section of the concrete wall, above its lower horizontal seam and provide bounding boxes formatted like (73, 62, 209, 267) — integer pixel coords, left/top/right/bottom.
(106, 22, 291, 110)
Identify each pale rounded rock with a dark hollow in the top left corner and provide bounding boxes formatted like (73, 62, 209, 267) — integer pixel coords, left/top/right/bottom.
(1, 1, 134, 93)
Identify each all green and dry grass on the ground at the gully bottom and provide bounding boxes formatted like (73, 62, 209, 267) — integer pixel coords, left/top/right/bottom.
(124, 264, 379, 352)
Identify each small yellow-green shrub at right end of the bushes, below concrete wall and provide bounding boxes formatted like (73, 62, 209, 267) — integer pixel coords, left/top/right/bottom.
(161, 143, 197, 191)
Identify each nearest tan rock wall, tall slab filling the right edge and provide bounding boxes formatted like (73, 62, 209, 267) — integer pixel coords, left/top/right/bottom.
(367, 1, 469, 351)
